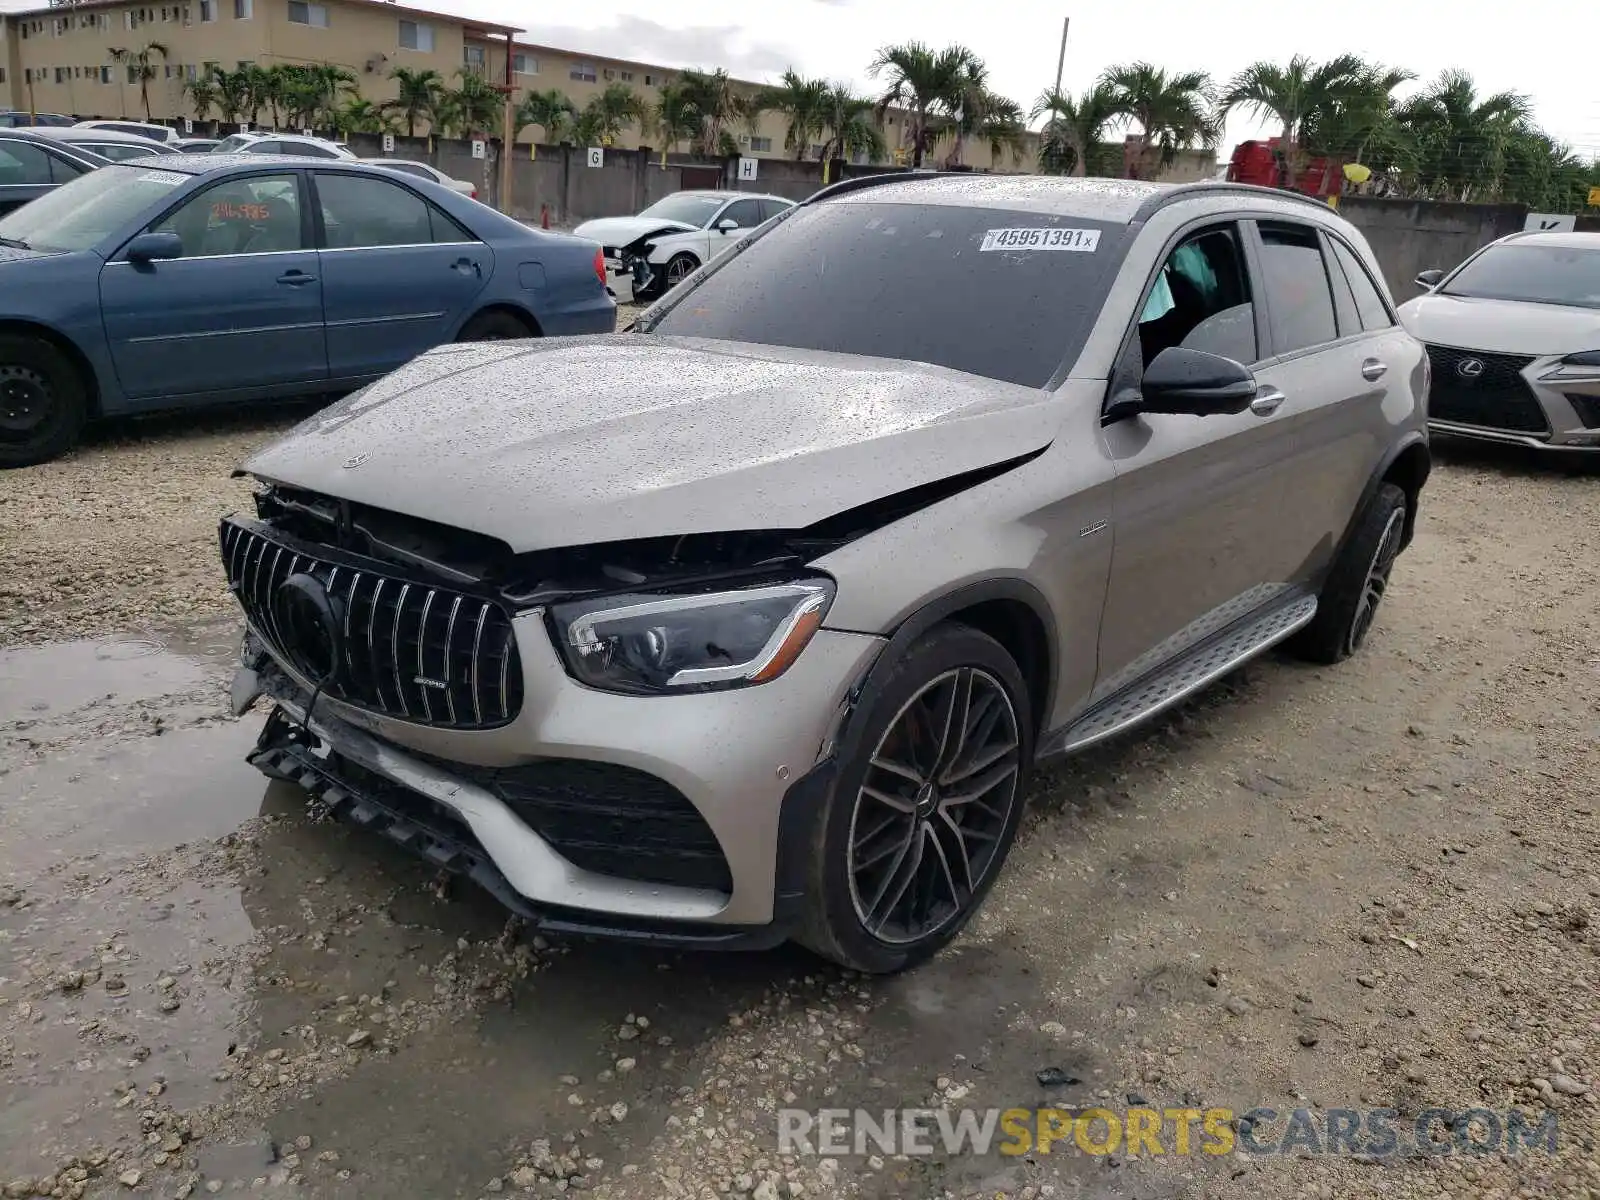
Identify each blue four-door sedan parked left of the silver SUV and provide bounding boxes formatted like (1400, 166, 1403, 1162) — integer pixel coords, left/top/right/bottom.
(0, 155, 616, 467)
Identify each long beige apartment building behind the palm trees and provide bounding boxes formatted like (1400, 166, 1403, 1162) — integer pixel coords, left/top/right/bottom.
(0, 0, 1034, 171)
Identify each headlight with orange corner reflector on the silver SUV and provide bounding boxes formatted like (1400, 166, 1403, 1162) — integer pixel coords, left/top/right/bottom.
(550, 578, 834, 696)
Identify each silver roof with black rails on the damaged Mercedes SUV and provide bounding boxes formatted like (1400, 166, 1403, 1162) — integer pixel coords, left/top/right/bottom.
(808, 171, 1338, 224)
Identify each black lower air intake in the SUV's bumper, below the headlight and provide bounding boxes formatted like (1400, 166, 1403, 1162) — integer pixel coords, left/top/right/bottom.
(448, 758, 733, 893)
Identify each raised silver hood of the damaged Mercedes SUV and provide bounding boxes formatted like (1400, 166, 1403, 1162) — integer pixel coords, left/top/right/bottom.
(243, 334, 1061, 554)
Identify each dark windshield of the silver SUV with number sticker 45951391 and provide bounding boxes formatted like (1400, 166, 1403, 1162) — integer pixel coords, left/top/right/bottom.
(648, 200, 1126, 387)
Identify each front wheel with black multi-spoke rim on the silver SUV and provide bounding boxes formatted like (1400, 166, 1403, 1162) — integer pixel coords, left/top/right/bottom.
(797, 624, 1034, 974)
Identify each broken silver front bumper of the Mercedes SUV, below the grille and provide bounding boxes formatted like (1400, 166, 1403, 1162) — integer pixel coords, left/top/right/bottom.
(234, 620, 882, 947)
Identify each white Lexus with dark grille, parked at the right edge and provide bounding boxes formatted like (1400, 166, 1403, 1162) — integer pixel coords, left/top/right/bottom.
(1400, 234, 1600, 453)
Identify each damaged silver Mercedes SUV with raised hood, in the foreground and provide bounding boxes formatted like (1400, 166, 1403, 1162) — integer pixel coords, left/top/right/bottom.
(221, 174, 1429, 971)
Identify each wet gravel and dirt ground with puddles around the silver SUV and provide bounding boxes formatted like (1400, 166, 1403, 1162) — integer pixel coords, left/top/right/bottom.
(0, 430, 1600, 1200)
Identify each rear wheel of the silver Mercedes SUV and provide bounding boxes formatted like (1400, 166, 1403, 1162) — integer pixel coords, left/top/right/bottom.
(1290, 483, 1406, 664)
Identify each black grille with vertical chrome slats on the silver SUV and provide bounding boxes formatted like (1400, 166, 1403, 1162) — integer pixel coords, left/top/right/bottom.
(221, 520, 522, 730)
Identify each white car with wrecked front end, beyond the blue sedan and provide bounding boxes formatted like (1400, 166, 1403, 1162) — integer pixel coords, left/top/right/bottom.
(573, 190, 795, 301)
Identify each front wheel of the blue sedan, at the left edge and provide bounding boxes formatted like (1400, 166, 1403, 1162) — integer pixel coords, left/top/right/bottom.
(0, 334, 90, 469)
